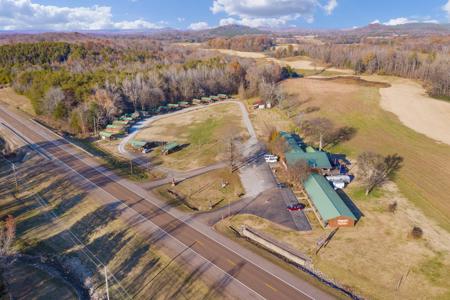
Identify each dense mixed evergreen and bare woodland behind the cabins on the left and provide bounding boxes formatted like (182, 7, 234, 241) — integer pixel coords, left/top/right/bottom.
(0, 39, 286, 134)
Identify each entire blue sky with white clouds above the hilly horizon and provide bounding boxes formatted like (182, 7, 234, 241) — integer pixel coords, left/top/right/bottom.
(0, 0, 450, 31)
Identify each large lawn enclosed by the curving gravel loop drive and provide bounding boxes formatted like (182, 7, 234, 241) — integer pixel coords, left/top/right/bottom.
(136, 103, 248, 170)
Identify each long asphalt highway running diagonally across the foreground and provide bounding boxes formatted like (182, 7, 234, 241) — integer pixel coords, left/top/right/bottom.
(0, 106, 333, 300)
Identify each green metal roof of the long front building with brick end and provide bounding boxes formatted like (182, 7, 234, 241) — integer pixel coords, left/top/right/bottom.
(304, 174, 357, 222)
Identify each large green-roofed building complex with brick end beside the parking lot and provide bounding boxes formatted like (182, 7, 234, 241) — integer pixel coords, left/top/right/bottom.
(280, 132, 358, 227)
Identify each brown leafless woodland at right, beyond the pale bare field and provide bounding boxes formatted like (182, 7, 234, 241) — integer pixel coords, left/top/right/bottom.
(273, 36, 450, 97)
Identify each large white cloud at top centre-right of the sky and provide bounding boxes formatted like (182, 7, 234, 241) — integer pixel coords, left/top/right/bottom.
(211, 0, 337, 27)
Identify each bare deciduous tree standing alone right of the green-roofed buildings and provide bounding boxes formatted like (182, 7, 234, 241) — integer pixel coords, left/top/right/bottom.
(357, 152, 403, 196)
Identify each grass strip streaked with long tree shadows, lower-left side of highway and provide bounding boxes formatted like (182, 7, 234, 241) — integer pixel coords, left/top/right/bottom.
(0, 157, 215, 299)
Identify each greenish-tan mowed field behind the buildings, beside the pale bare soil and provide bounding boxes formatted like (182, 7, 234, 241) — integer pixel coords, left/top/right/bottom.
(283, 79, 450, 231)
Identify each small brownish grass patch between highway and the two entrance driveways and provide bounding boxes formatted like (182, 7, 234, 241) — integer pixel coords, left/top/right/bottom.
(155, 168, 244, 211)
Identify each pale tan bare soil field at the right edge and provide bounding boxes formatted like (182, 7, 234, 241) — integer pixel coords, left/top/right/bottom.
(363, 76, 450, 145)
